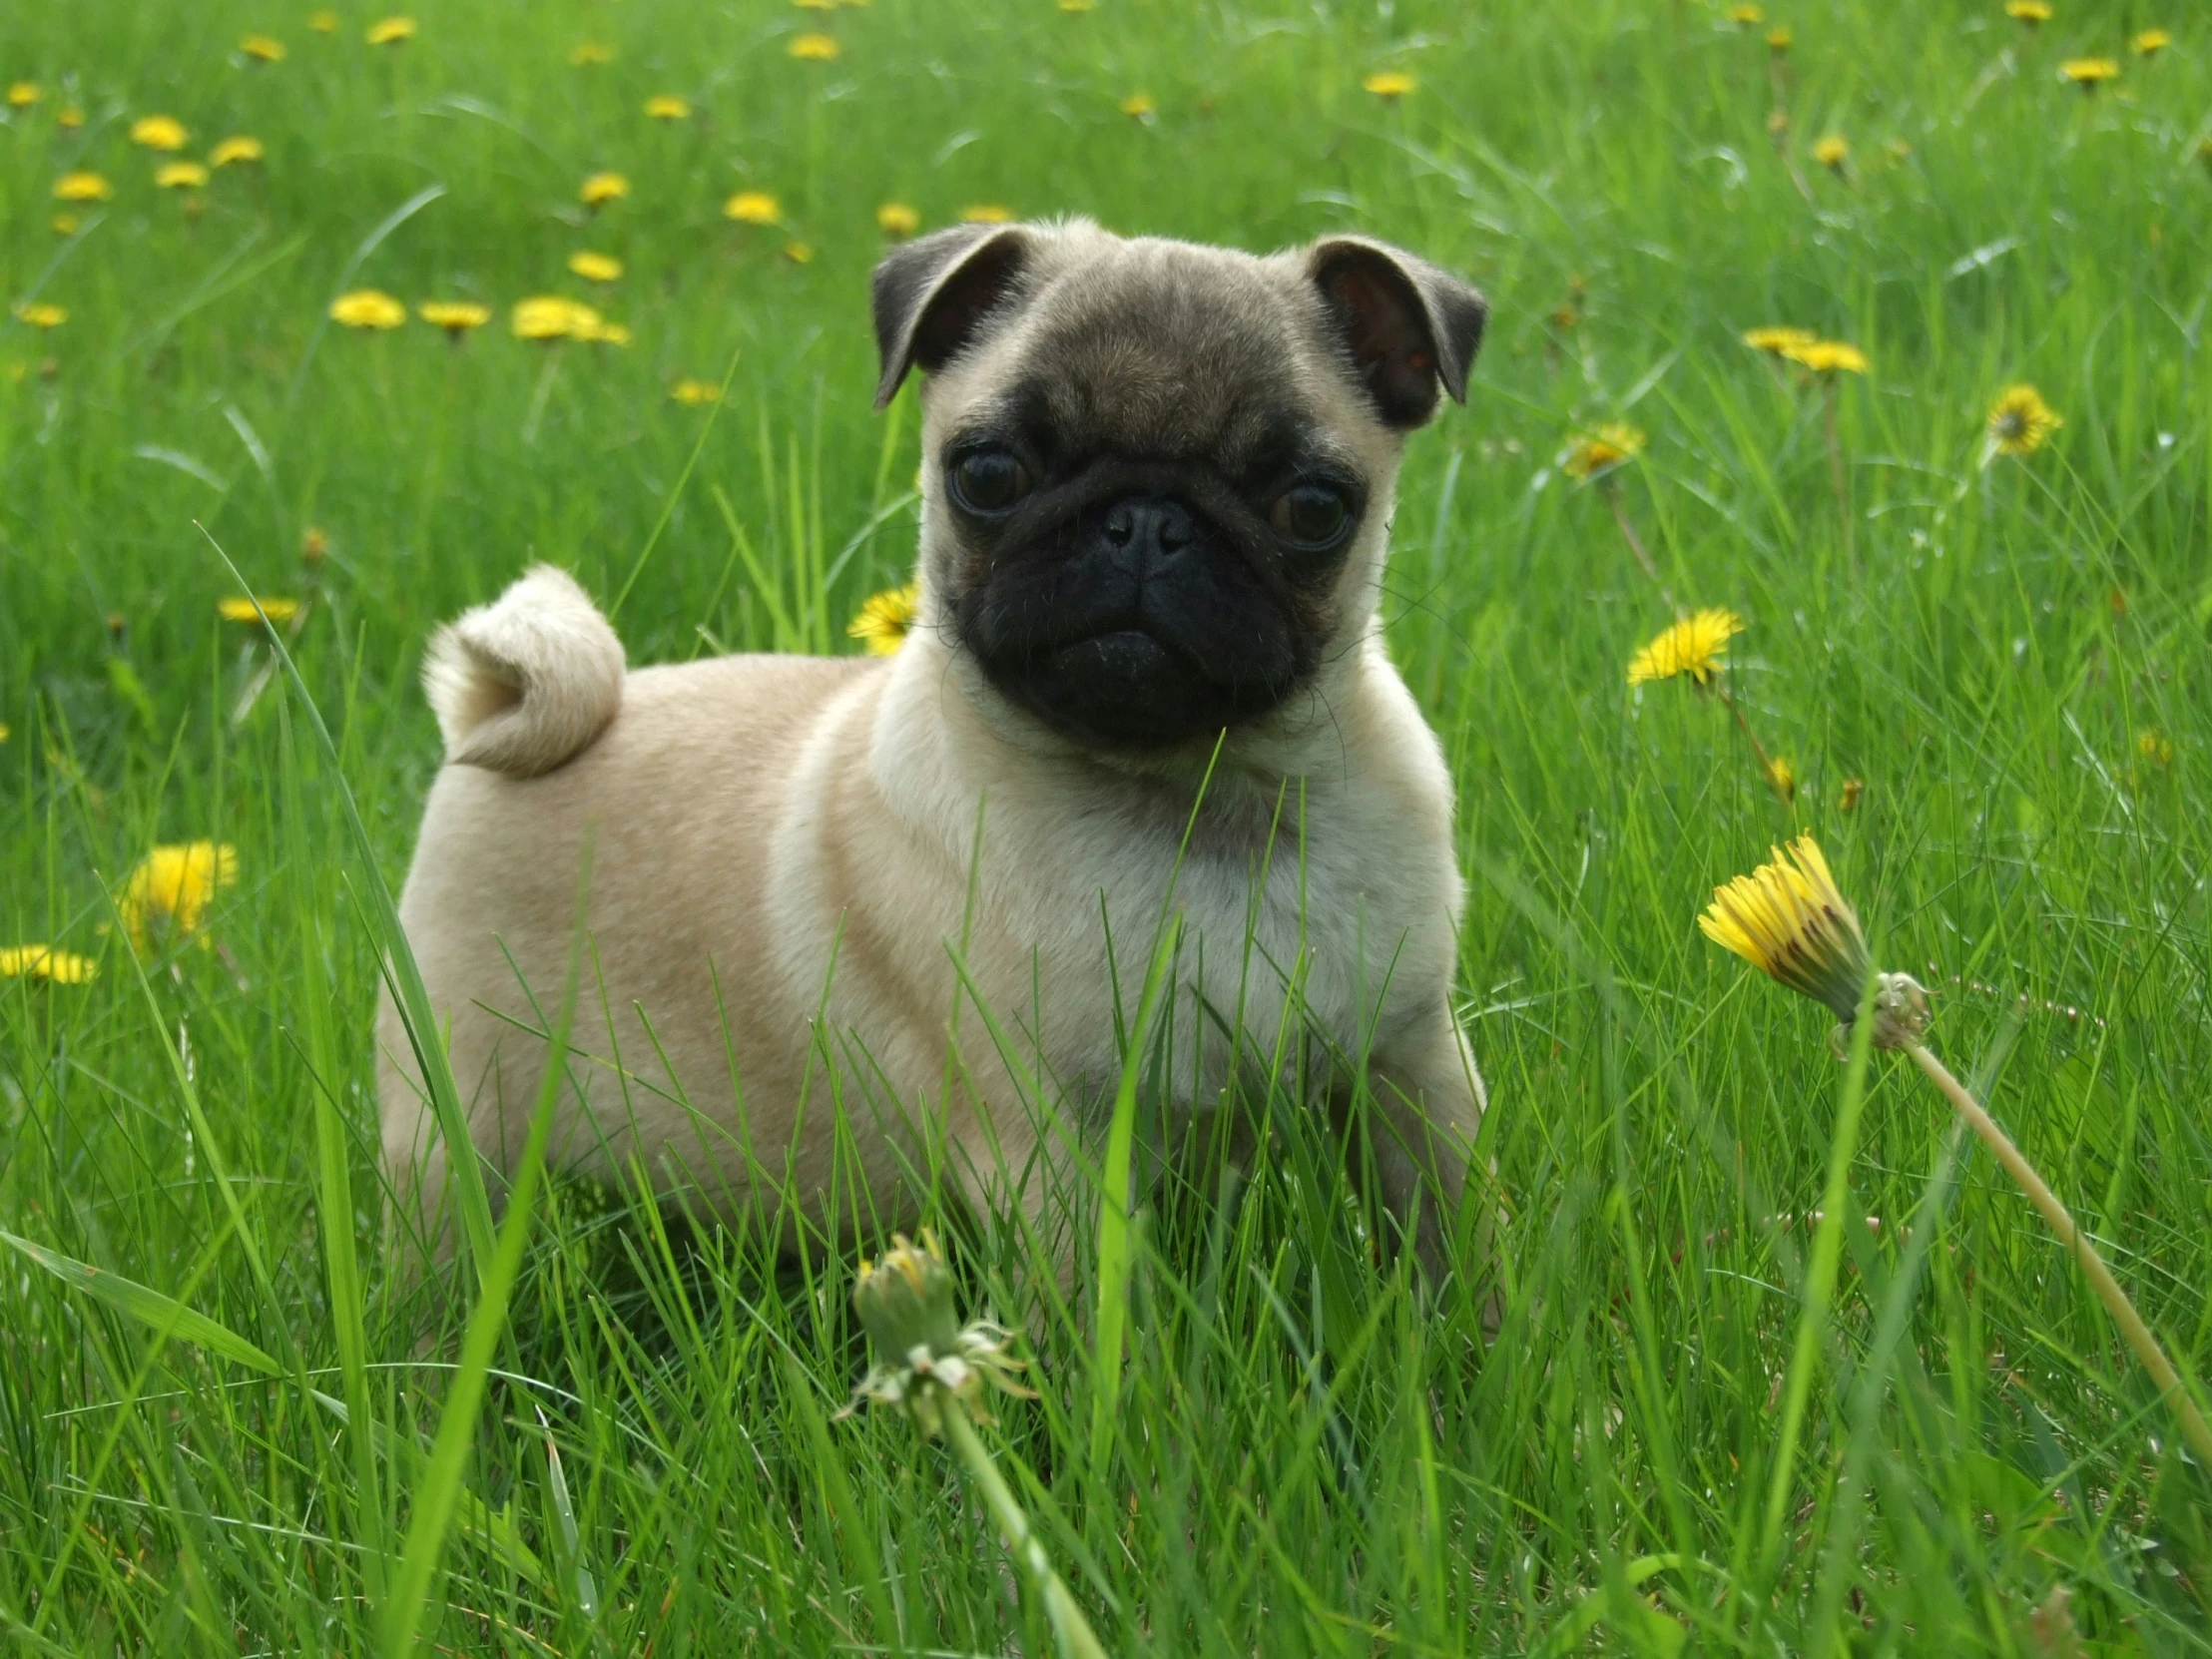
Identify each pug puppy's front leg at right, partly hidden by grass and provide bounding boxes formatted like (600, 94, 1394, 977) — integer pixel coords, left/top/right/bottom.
(1367, 1006, 1488, 1281)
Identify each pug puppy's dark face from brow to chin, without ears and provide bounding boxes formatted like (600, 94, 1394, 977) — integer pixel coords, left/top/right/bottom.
(935, 351, 1367, 750)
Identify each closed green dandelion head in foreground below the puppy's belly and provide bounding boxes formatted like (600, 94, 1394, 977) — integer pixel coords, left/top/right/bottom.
(845, 1228, 1033, 1435)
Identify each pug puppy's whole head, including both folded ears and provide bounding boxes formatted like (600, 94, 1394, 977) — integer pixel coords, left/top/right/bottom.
(873, 224, 1482, 752)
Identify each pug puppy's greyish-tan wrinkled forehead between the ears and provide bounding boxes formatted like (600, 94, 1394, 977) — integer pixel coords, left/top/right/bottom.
(991, 244, 1321, 471)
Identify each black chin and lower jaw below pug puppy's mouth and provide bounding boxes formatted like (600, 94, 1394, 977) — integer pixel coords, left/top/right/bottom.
(982, 624, 1290, 752)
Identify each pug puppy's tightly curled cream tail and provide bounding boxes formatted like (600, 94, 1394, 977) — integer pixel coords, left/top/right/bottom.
(422, 564, 624, 779)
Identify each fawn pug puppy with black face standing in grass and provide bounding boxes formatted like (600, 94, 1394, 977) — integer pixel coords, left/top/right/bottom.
(378, 222, 1484, 1266)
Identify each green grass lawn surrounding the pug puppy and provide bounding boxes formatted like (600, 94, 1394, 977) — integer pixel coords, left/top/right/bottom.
(0, 0, 2212, 1659)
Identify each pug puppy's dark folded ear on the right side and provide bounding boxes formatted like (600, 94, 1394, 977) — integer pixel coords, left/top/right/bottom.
(1305, 237, 1491, 427)
